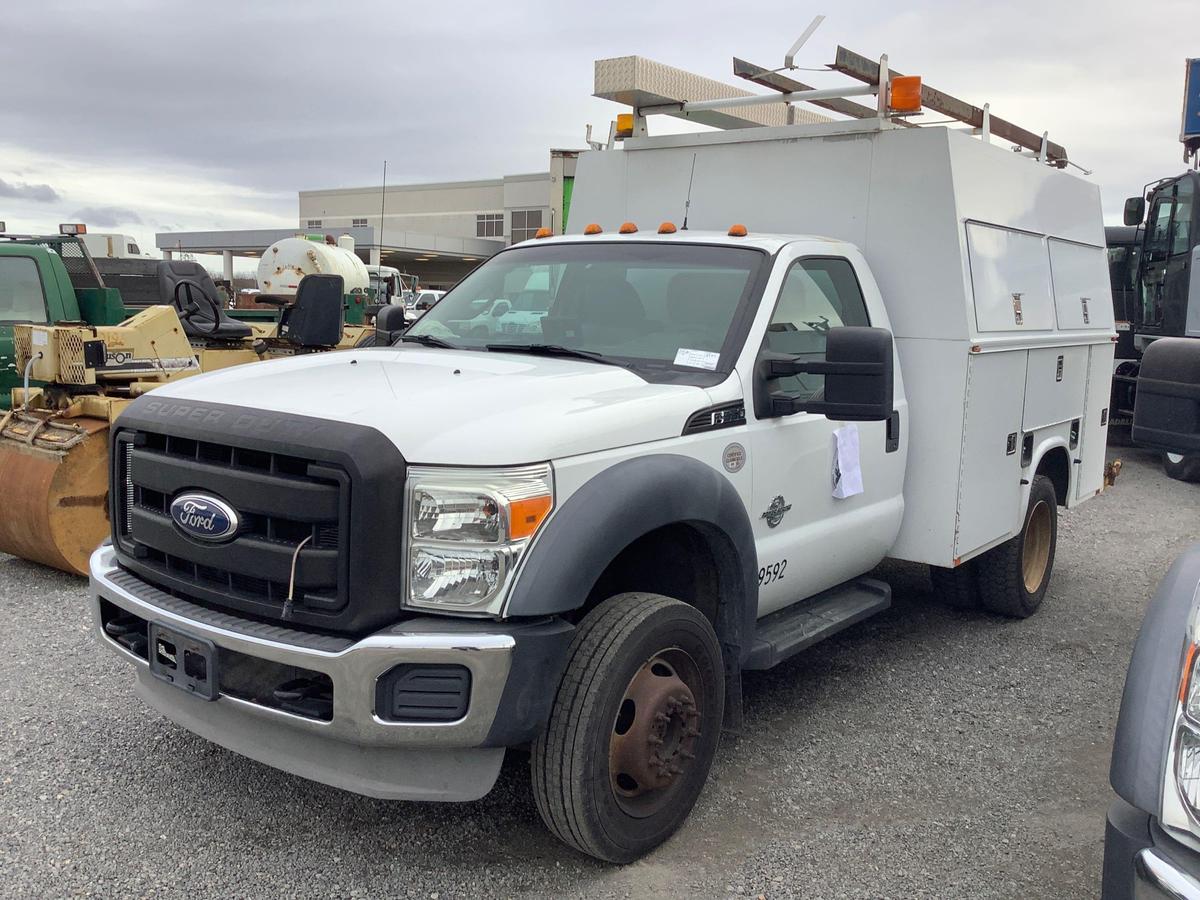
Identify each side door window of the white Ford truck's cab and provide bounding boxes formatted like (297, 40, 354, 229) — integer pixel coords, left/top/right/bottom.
(766, 258, 871, 400)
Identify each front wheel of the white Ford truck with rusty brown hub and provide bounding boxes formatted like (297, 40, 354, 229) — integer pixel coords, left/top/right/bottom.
(530, 594, 725, 863)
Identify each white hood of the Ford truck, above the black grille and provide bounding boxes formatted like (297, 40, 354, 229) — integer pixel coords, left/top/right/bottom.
(154, 346, 712, 466)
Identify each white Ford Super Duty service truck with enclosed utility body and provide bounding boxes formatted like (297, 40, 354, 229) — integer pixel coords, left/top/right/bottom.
(90, 51, 1114, 862)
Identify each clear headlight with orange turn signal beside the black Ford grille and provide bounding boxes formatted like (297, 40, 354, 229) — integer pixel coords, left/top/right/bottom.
(406, 464, 554, 612)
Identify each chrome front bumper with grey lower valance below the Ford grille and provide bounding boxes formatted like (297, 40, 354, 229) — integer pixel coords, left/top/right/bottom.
(89, 544, 516, 800)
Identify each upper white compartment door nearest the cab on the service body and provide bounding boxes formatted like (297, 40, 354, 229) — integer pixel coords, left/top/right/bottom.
(967, 222, 1054, 331)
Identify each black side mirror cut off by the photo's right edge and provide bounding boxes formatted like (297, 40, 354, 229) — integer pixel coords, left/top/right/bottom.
(1132, 337, 1200, 455)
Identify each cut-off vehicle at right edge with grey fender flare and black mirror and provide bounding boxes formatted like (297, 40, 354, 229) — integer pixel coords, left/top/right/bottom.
(1102, 337, 1200, 900)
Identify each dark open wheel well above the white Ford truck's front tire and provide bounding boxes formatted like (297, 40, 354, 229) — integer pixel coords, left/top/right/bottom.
(570, 522, 732, 634)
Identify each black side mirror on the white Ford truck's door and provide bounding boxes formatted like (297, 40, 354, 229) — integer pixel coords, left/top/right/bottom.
(755, 325, 894, 422)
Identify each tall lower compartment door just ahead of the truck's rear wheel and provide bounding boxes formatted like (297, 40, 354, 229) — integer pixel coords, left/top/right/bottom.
(947, 350, 1027, 558)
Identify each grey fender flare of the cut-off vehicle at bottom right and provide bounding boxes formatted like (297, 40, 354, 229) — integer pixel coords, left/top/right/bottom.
(1109, 544, 1200, 817)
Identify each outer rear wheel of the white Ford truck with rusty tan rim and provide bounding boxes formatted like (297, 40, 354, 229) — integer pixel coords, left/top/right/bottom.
(978, 475, 1058, 619)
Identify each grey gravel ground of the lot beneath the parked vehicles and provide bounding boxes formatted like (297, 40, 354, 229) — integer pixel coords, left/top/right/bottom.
(0, 449, 1200, 900)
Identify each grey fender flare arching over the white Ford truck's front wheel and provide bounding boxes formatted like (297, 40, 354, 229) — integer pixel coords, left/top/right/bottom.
(504, 454, 758, 654)
